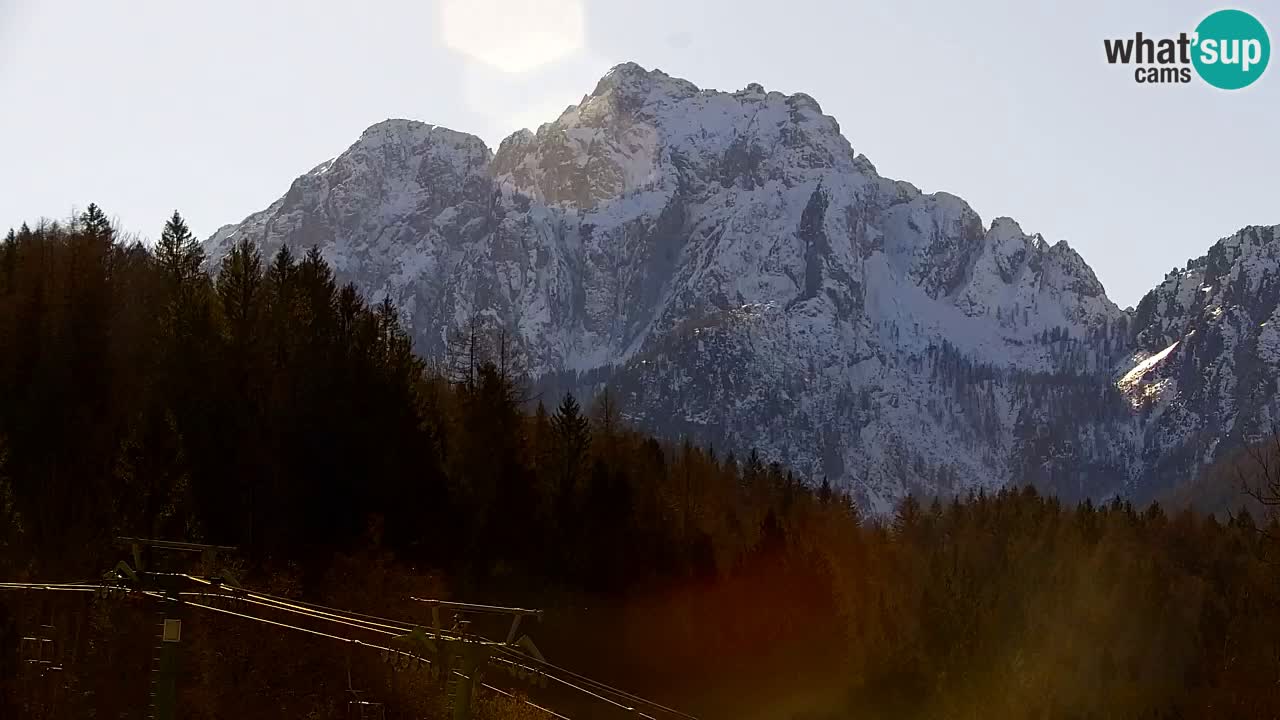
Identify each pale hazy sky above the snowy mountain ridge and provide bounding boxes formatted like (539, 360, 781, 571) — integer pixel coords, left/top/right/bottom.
(0, 0, 1280, 306)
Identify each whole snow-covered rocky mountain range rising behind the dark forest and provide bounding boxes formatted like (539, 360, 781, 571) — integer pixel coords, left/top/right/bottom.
(206, 64, 1280, 510)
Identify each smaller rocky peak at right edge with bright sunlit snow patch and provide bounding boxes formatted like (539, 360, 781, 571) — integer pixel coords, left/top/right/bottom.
(1119, 225, 1280, 499)
